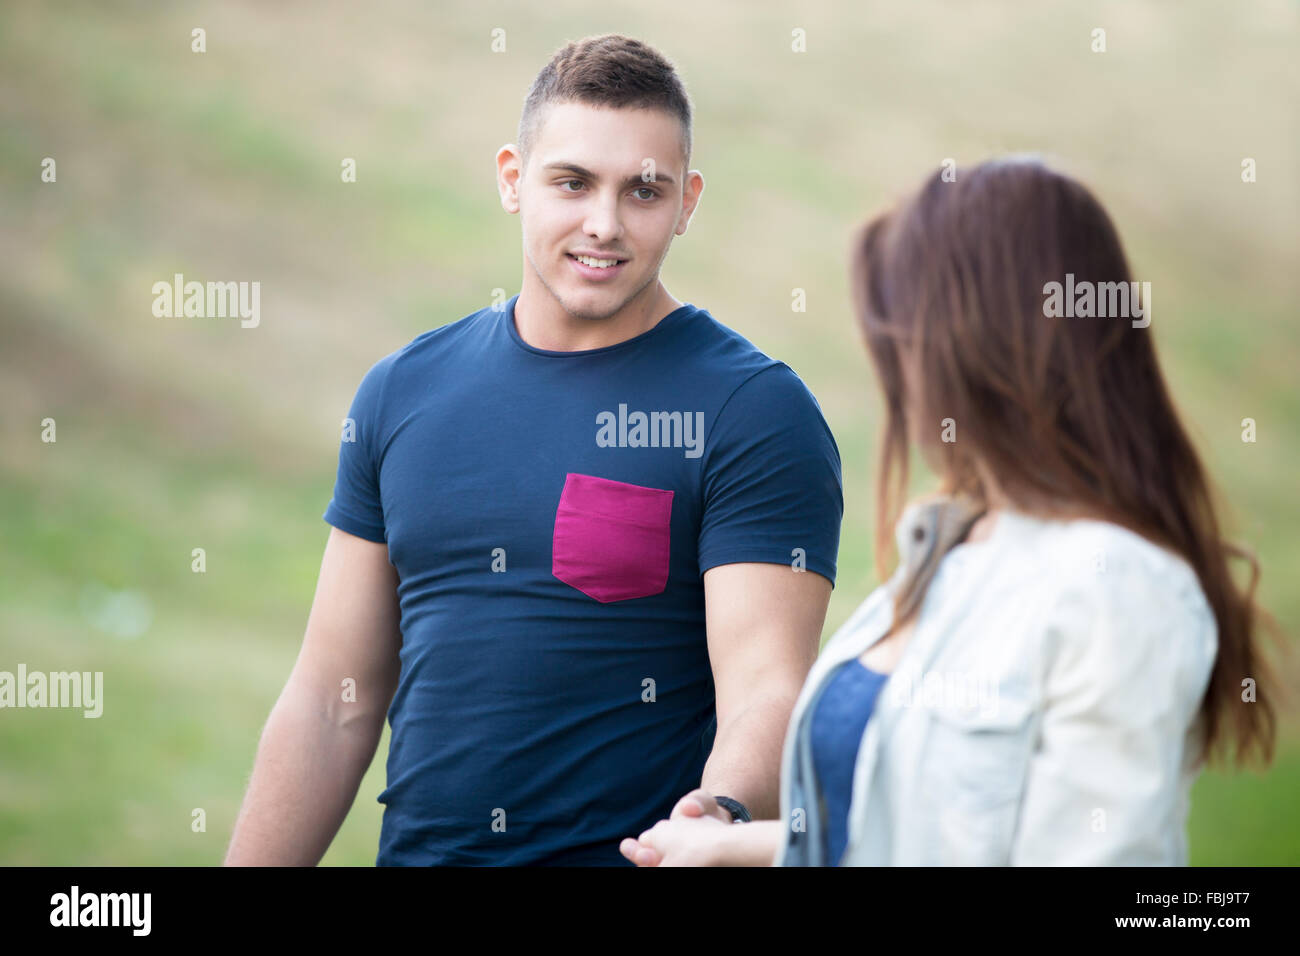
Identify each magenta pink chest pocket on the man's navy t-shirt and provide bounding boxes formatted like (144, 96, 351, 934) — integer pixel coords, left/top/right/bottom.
(551, 473, 672, 604)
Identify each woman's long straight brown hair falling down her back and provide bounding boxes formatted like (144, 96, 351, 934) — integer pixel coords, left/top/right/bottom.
(853, 157, 1281, 765)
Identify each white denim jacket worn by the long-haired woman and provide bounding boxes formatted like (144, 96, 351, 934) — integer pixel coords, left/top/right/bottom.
(775, 499, 1218, 866)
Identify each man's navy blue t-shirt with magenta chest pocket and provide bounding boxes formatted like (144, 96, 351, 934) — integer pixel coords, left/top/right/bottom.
(324, 295, 842, 865)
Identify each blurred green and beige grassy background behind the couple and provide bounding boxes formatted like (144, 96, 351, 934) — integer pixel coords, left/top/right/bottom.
(0, 0, 1300, 865)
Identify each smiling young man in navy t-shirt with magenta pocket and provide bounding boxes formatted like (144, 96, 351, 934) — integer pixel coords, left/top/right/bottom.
(226, 35, 842, 865)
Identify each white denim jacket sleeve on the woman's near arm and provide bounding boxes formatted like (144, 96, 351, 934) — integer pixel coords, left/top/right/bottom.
(1010, 561, 1217, 866)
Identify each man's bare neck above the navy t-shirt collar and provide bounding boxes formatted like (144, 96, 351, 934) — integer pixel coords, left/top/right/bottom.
(515, 282, 683, 352)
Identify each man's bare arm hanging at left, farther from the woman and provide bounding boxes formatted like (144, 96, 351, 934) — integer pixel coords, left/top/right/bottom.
(225, 528, 402, 866)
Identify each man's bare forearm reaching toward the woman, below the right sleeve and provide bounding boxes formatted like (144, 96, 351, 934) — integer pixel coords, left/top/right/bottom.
(701, 563, 831, 819)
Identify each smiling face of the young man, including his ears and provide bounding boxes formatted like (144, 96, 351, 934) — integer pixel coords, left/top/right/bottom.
(498, 103, 703, 320)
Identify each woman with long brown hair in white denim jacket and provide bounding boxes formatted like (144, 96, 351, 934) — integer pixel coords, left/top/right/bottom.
(623, 159, 1275, 866)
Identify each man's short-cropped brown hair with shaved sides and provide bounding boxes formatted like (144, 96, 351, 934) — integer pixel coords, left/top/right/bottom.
(517, 34, 692, 165)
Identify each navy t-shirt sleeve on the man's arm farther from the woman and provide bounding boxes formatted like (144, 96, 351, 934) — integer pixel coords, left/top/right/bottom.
(322, 355, 393, 542)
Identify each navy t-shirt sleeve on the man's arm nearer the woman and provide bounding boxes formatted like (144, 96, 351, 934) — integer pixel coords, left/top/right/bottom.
(699, 363, 844, 585)
